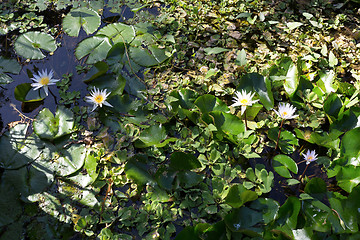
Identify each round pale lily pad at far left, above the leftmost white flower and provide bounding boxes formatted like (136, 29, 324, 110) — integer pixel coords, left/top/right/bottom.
(14, 32, 57, 59)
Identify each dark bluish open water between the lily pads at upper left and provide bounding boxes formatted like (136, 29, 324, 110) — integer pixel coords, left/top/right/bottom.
(0, 6, 139, 132)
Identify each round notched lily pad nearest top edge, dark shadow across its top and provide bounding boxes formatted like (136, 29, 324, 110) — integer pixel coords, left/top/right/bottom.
(62, 8, 101, 37)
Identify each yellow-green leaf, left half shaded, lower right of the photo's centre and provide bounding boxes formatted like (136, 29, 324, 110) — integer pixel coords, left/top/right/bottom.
(225, 184, 258, 208)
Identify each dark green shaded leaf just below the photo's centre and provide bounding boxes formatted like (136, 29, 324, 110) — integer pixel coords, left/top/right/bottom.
(169, 152, 202, 171)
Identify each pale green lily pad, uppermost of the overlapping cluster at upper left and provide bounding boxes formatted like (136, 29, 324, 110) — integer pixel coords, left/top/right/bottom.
(96, 23, 136, 44)
